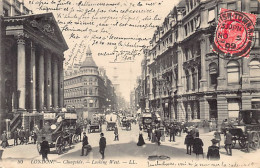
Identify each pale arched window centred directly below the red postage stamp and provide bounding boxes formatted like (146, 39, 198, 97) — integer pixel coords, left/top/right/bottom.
(227, 61, 240, 84)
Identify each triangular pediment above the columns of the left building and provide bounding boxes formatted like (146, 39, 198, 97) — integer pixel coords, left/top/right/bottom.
(5, 13, 68, 51)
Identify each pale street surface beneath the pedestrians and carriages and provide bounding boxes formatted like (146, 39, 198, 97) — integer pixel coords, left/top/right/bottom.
(1, 124, 260, 167)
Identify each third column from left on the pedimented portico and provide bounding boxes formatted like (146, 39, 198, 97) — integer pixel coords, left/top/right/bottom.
(38, 47, 44, 110)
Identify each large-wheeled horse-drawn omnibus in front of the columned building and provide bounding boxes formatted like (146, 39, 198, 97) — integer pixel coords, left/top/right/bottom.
(37, 113, 77, 154)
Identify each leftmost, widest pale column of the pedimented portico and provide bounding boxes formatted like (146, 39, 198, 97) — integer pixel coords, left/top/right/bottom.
(17, 36, 26, 109)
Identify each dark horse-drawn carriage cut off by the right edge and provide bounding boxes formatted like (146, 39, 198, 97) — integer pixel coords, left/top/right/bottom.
(228, 109, 260, 150)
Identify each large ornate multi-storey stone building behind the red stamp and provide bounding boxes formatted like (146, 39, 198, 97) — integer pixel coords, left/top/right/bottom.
(142, 0, 260, 123)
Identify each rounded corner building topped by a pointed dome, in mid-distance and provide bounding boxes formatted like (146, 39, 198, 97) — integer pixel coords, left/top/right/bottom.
(64, 47, 116, 119)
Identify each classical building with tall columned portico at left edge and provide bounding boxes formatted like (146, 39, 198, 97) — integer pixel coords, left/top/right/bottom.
(0, 0, 68, 132)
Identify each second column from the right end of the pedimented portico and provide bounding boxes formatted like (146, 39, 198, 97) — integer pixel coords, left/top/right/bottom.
(52, 55, 59, 108)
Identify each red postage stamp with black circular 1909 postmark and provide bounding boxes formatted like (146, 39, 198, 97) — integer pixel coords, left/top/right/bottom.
(213, 8, 256, 57)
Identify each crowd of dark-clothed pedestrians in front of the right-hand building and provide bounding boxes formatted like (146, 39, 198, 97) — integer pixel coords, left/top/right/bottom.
(137, 119, 236, 160)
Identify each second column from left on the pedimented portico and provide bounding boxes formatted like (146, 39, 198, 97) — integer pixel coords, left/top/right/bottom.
(29, 42, 36, 110)
